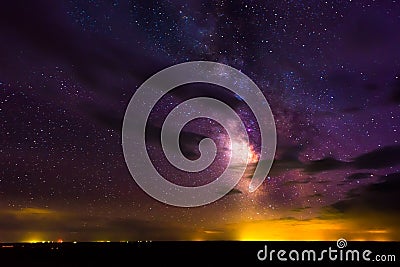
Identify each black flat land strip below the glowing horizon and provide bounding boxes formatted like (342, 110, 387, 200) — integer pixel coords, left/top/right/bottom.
(0, 241, 400, 266)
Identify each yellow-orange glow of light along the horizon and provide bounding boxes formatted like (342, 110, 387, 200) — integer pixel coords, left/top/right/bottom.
(0, 205, 399, 243)
